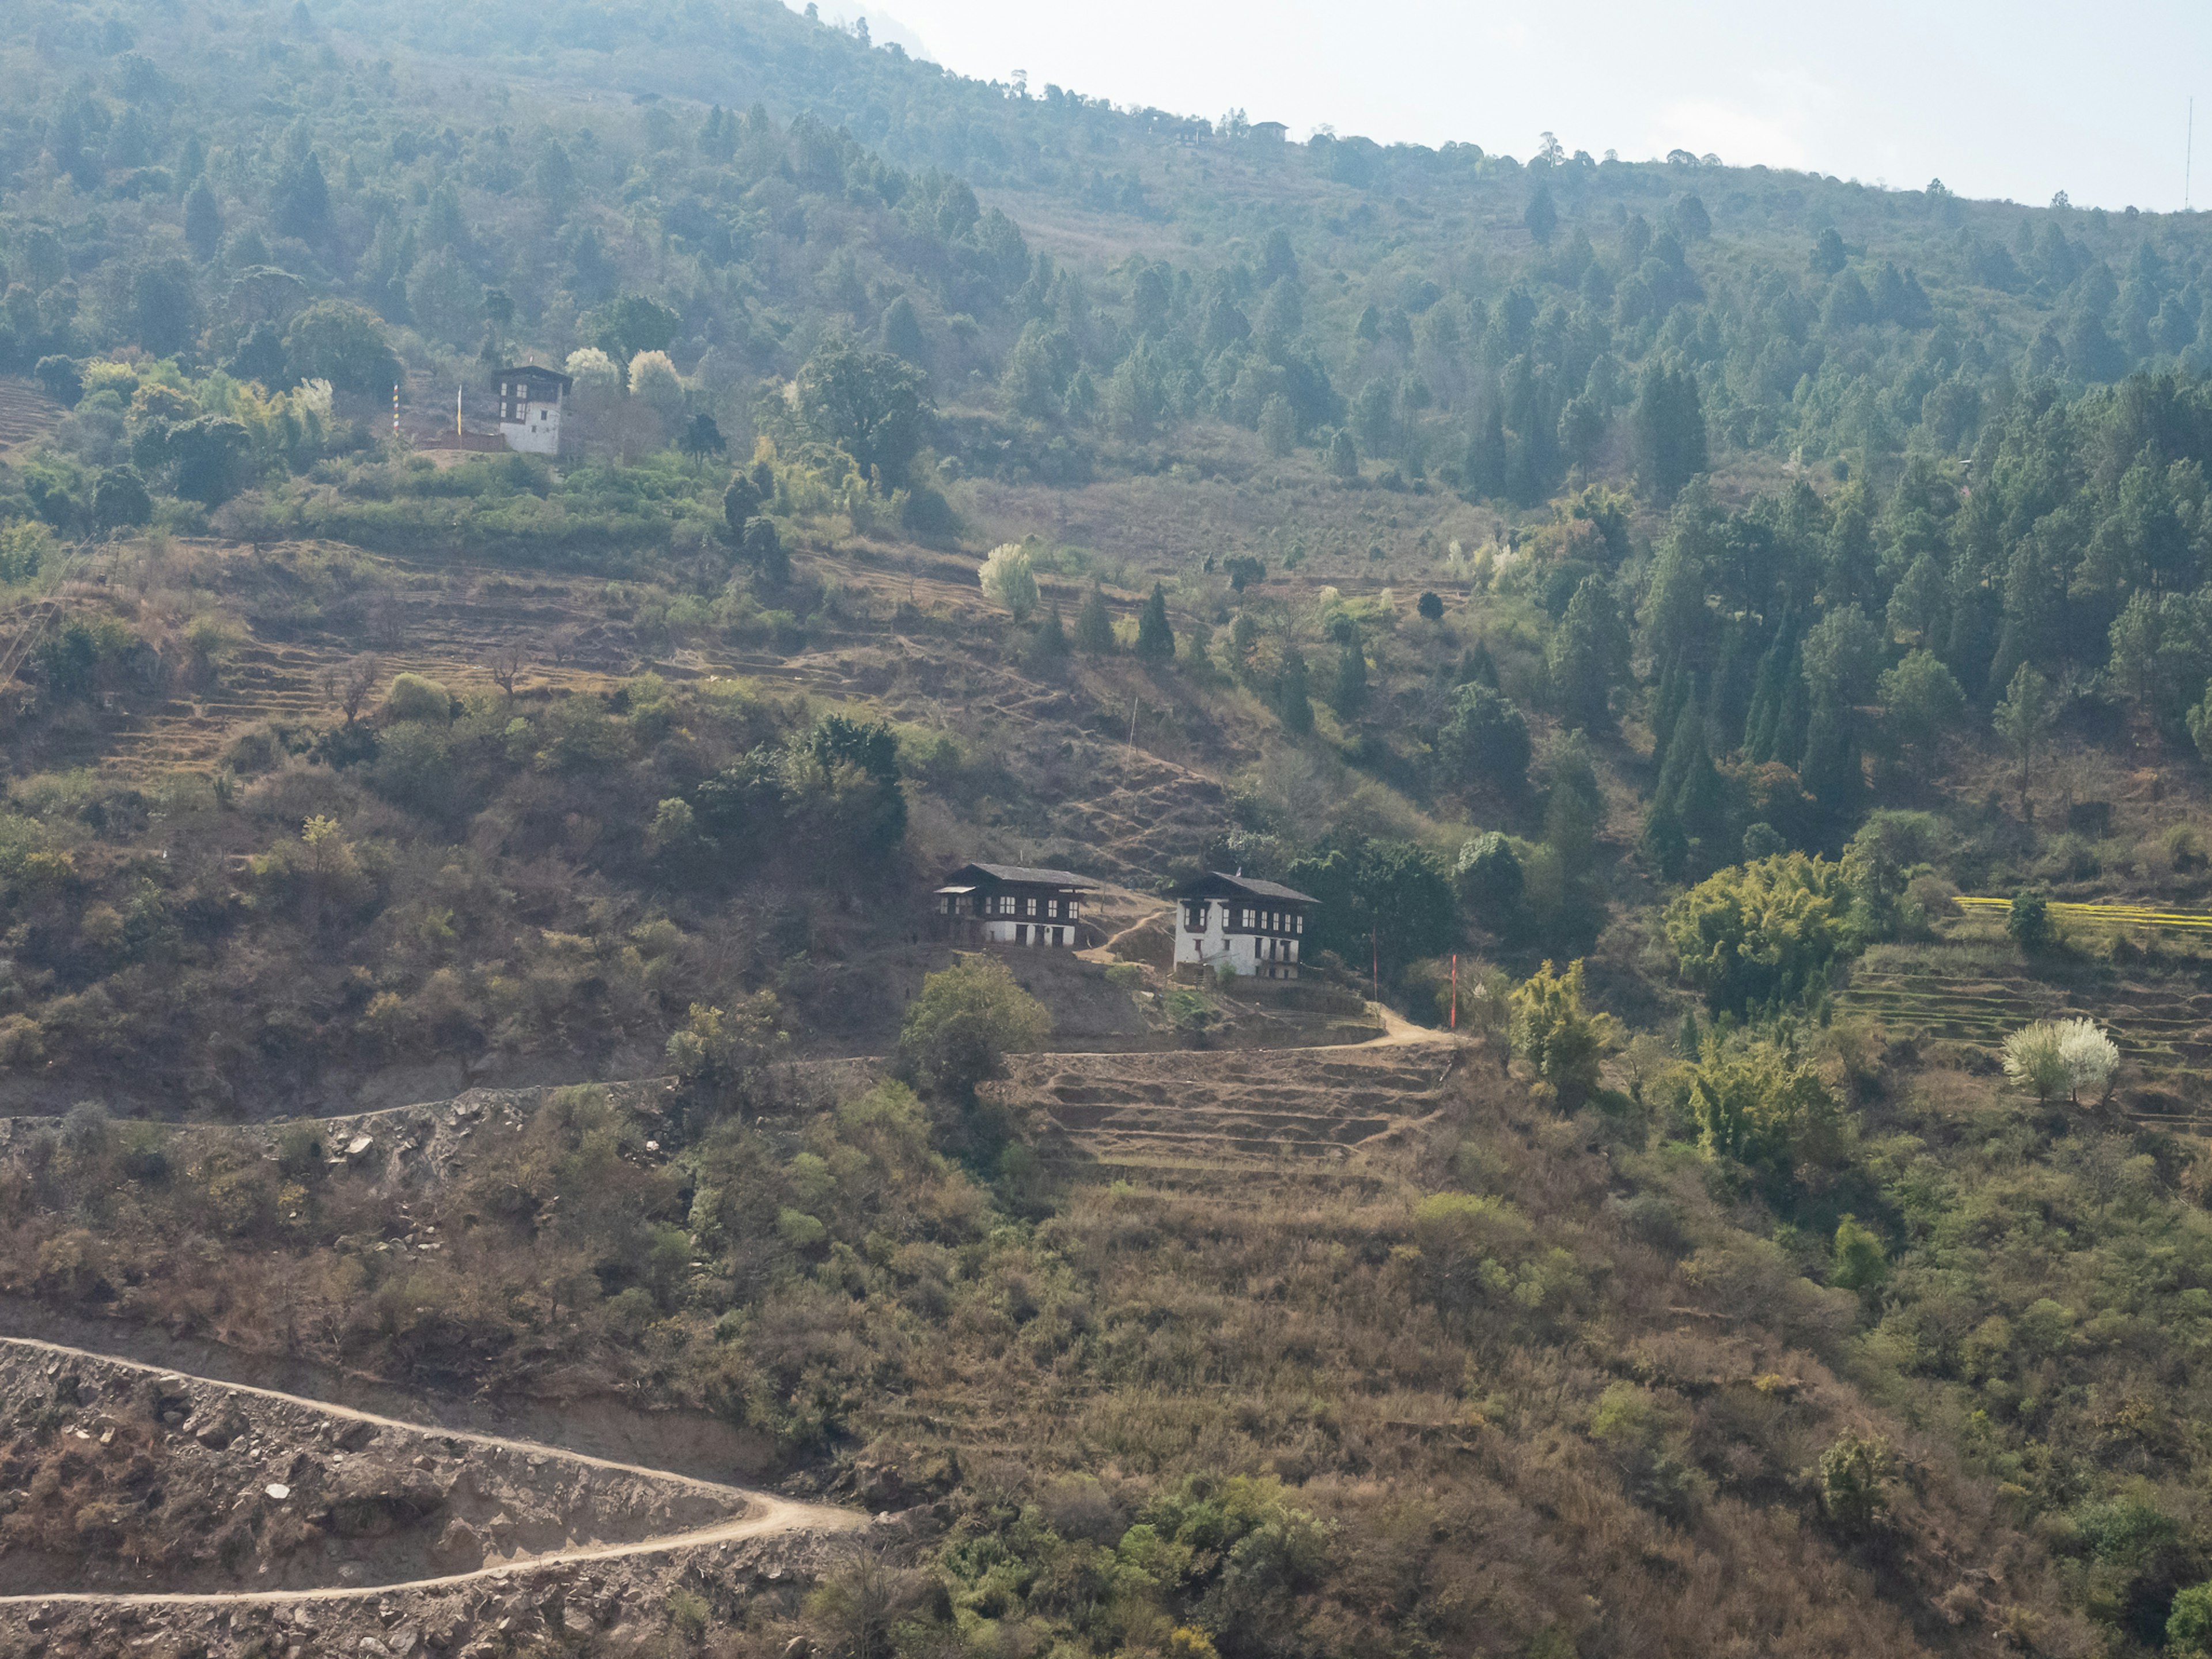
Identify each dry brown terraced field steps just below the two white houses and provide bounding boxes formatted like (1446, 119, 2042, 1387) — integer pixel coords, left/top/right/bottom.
(995, 1044, 1458, 1177)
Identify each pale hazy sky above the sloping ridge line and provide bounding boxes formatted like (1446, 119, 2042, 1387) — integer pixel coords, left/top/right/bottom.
(821, 0, 2212, 210)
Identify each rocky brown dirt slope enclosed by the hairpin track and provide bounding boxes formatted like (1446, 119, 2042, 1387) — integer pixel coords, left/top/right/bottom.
(0, 1343, 748, 1595)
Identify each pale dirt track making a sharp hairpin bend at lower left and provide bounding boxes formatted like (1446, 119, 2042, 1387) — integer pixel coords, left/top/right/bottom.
(0, 1336, 867, 1608)
